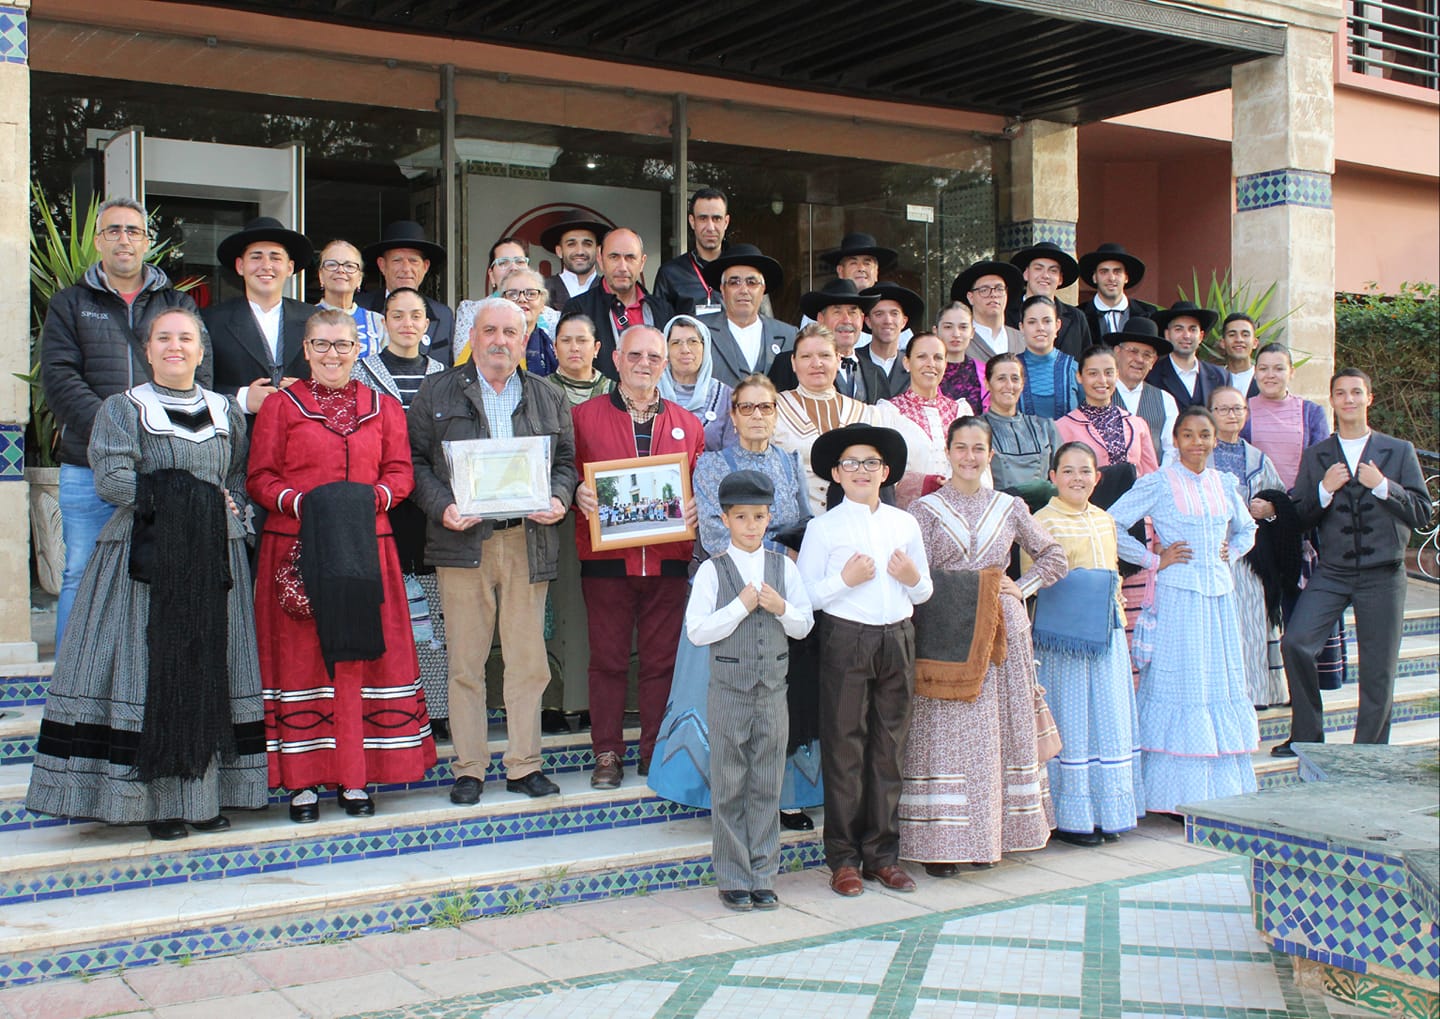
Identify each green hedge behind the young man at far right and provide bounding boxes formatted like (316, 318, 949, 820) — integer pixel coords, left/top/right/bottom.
(1335, 284, 1440, 450)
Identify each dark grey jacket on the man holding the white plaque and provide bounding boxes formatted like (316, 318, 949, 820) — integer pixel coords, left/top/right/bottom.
(408, 361, 576, 583)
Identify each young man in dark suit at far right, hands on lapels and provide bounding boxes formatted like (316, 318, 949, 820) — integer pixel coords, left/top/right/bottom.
(1270, 368, 1430, 757)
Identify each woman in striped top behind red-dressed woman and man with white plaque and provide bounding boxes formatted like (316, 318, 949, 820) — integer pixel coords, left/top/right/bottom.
(354, 286, 449, 738)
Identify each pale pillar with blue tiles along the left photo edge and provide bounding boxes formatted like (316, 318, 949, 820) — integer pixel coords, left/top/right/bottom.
(0, 0, 36, 664)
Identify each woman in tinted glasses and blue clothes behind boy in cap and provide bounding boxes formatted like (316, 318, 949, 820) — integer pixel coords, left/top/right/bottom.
(649, 374, 825, 828)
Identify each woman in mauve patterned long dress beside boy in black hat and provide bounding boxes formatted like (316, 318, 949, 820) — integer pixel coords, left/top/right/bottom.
(900, 417, 1067, 878)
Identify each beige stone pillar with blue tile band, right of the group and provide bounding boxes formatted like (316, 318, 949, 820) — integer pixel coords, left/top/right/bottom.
(1230, 22, 1338, 402)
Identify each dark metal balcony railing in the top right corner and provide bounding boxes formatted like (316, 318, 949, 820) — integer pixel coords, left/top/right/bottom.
(1346, 0, 1440, 89)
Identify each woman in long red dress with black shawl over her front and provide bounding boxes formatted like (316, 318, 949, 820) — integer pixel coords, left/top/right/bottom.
(248, 311, 435, 823)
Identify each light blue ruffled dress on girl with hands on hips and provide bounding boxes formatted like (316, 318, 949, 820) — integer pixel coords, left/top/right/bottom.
(1110, 463, 1260, 813)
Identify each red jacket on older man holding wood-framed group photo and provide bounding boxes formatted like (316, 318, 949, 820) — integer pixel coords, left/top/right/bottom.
(572, 391, 706, 577)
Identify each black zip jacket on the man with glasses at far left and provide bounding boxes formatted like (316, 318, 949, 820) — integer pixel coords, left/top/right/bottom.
(40, 263, 215, 468)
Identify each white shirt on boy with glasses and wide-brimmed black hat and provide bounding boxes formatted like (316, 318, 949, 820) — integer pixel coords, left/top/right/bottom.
(799, 499, 935, 626)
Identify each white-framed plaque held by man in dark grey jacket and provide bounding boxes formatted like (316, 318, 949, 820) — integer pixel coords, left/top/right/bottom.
(444, 435, 550, 520)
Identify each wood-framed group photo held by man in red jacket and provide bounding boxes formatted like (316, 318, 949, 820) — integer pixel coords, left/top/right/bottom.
(585, 453, 696, 551)
